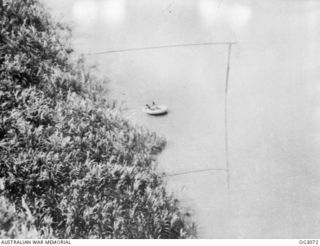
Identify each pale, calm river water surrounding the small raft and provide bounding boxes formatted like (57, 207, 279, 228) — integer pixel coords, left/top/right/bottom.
(44, 0, 320, 238)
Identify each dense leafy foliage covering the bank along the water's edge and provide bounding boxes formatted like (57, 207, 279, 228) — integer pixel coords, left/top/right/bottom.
(0, 0, 193, 238)
